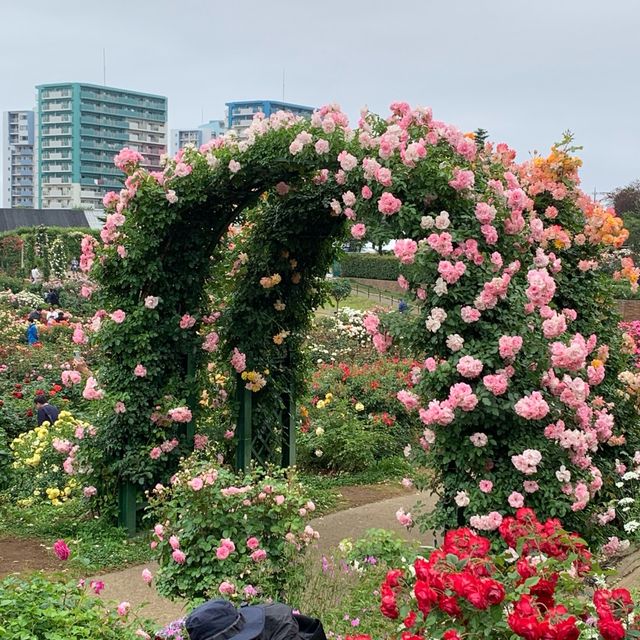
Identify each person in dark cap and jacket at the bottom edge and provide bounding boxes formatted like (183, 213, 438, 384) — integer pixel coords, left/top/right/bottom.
(185, 600, 327, 640)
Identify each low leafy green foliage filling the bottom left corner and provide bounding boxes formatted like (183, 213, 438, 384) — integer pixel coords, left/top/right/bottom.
(0, 575, 153, 640)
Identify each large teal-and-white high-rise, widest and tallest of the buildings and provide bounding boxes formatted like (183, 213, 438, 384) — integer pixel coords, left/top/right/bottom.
(36, 82, 167, 209)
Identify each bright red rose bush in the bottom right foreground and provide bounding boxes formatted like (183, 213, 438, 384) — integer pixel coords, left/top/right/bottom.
(372, 508, 638, 640)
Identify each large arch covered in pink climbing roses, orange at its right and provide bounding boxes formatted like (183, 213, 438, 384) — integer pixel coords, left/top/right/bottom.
(78, 103, 640, 535)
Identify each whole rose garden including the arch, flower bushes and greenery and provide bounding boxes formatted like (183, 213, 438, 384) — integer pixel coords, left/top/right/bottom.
(0, 103, 640, 640)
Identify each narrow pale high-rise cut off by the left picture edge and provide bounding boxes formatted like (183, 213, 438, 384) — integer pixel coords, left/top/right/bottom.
(2, 111, 34, 209)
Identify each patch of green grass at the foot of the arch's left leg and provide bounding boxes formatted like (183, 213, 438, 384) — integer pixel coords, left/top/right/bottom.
(0, 500, 153, 575)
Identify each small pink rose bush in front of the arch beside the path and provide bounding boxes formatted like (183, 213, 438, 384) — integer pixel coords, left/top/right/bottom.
(149, 457, 315, 600)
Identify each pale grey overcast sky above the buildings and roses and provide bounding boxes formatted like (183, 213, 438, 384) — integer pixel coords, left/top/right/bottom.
(0, 0, 640, 191)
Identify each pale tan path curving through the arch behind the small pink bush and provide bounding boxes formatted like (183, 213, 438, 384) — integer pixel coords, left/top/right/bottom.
(90, 493, 435, 624)
